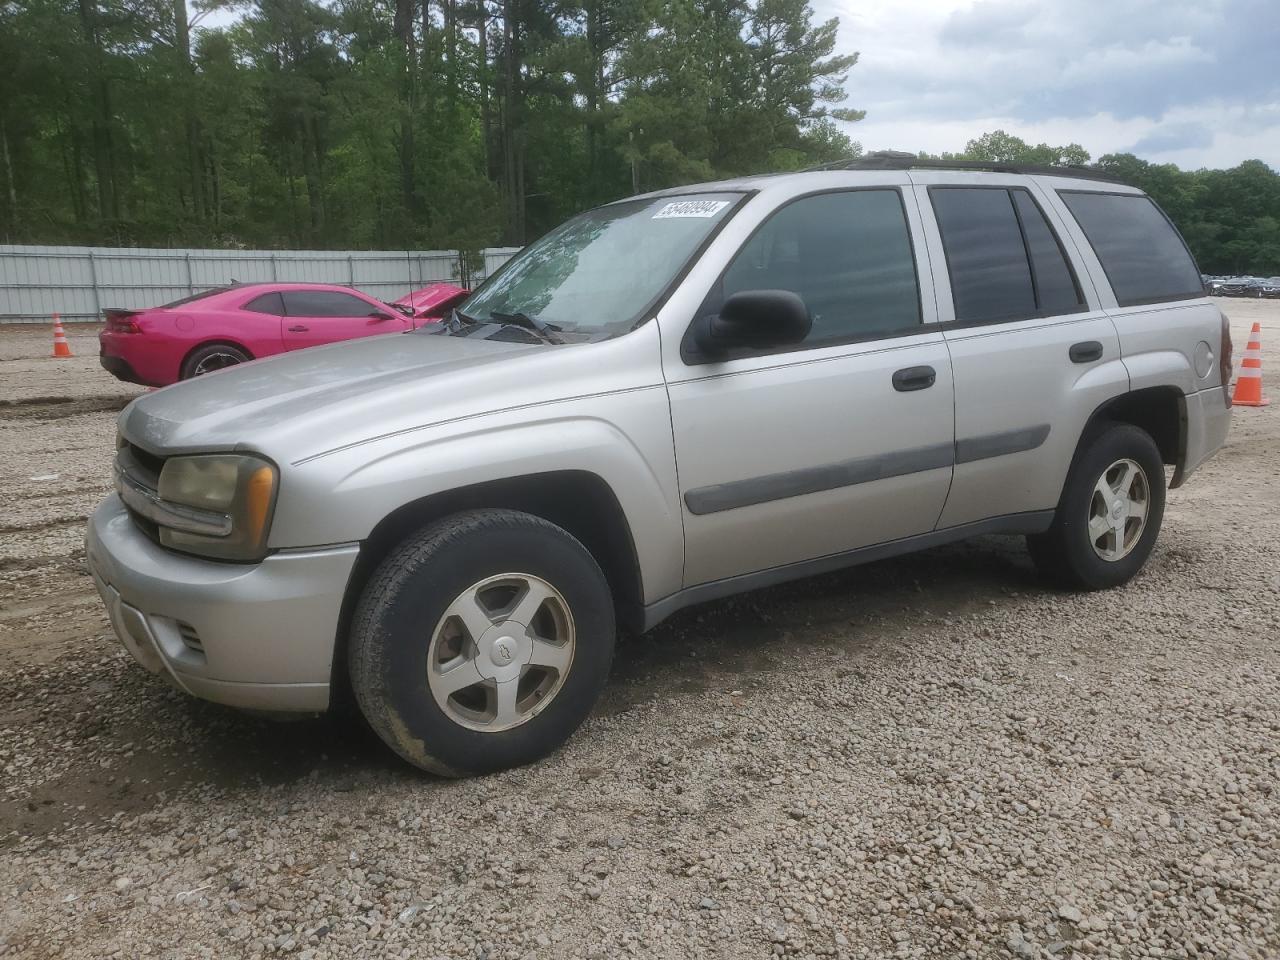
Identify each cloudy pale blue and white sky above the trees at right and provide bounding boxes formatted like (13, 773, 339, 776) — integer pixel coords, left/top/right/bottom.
(813, 0, 1280, 168)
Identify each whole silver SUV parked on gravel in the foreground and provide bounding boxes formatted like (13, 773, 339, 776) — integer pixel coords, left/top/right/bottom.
(87, 159, 1231, 776)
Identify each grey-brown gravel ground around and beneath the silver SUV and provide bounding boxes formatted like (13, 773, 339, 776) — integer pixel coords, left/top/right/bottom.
(0, 309, 1280, 960)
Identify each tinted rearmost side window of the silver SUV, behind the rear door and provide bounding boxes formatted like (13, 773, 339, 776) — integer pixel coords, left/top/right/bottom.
(1061, 191, 1204, 306)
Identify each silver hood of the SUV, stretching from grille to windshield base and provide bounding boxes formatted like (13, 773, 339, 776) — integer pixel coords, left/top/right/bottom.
(120, 324, 663, 466)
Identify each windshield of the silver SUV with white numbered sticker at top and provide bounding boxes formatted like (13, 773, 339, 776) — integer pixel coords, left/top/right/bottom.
(458, 193, 742, 342)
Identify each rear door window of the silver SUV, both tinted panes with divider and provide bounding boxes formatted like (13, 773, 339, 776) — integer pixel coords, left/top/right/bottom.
(929, 187, 1084, 324)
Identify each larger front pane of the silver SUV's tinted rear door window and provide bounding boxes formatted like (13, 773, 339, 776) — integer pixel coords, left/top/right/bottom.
(929, 187, 1037, 323)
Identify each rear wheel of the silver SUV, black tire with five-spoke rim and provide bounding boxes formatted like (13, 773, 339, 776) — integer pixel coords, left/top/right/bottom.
(1027, 422, 1165, 590)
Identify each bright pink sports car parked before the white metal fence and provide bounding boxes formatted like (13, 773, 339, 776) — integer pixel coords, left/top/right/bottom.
(99, 283, 467, 387)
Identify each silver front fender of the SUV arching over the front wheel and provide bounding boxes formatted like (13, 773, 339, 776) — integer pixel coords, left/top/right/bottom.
(270, 385, 684, 602)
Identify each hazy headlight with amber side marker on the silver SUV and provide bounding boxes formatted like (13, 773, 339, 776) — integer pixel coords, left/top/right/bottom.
(156, 453, 278, 561)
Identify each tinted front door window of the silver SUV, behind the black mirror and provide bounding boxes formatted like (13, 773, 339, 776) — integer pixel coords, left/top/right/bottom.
(721, 189, 920, 346)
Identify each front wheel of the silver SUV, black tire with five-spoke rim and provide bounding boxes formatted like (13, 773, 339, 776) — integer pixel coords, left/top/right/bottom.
(348, 509, 614, 777)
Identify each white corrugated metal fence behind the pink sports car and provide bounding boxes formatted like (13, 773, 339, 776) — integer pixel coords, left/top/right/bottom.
(0, 244, 518, 323)
